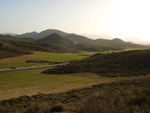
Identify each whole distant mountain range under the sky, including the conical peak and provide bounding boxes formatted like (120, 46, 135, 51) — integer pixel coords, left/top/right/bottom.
(0, 29, 149, 48)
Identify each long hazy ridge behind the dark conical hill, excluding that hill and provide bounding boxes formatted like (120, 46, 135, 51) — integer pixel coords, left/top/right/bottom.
(8, 29, 147, 48)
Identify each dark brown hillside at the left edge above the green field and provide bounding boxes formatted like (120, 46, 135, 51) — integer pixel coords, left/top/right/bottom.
(0, 35, 51, 59)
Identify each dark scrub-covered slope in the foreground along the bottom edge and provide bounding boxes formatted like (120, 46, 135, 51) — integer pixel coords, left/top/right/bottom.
(0, 76, 150, 113)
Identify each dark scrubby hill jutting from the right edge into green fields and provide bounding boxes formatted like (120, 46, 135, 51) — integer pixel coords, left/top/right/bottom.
(43, 50, 150, 76)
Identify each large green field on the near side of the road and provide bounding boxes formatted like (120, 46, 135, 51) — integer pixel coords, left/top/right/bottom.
(0, 69, 137, 100)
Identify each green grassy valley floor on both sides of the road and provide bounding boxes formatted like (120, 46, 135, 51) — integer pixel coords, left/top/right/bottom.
(0, 51, 143, 100)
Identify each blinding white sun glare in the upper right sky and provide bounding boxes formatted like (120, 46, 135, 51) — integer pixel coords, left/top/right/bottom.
(113, 0, 150, 41)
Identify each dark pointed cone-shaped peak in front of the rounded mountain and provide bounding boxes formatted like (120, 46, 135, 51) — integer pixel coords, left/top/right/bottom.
(36, 33, 74, 44)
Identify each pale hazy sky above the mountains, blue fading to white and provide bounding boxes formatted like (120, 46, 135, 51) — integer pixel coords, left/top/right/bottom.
(0, 0, 150, 41)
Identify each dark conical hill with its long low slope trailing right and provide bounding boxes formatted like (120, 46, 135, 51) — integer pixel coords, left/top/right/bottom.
(35, 33, 124, 52)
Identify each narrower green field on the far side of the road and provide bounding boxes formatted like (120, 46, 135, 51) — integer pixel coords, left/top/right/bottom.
(0, 51, 95, 69)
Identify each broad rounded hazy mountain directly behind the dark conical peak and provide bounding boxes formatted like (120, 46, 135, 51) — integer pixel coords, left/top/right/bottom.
(16, 29, 68, 38)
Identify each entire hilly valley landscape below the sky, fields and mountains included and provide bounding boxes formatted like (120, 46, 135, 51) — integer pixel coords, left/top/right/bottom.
(0, 30, 150, 113)
